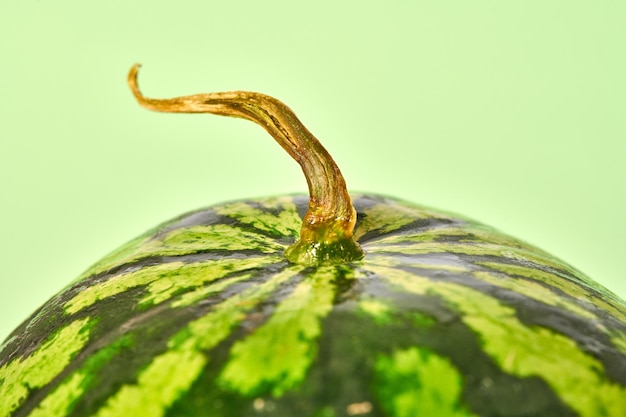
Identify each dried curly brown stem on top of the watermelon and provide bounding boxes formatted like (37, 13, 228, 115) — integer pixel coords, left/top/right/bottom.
(128, 64, 363, 265)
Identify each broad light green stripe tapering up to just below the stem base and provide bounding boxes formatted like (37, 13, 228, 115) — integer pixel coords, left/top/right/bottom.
(220, 267, 337, 396)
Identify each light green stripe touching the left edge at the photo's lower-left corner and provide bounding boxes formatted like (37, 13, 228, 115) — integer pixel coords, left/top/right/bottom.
(0, 317, 93, 417)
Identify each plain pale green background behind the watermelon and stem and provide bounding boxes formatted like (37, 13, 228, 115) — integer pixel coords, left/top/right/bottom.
(0, 0, 626, 339)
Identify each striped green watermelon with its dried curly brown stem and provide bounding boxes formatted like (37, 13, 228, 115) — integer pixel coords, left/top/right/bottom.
(0, 67, 626, 417)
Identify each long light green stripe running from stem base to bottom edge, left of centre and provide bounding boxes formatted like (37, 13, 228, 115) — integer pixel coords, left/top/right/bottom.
(91, 266, 302, 417)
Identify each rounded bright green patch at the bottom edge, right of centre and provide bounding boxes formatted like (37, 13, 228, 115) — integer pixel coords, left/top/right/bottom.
(375, 348, 474, 417)
